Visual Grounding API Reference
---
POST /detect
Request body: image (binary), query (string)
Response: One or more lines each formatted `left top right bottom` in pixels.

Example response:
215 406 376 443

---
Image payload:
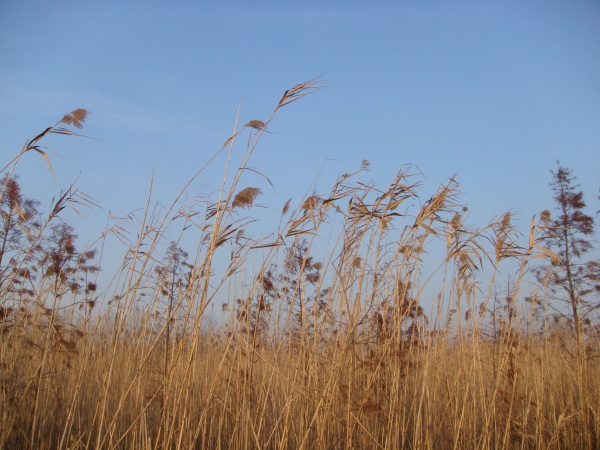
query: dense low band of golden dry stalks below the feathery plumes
2 326 600 448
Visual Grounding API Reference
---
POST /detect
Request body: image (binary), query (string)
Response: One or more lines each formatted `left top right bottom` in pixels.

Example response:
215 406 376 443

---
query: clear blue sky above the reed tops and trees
0 0 600 260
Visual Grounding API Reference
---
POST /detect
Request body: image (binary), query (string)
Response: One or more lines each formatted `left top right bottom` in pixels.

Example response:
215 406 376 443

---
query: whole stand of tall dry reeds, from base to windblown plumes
0 80 600 449
